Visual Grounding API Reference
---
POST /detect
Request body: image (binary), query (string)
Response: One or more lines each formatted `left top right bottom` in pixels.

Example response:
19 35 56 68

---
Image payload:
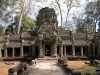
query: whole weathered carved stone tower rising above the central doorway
36 7 61 42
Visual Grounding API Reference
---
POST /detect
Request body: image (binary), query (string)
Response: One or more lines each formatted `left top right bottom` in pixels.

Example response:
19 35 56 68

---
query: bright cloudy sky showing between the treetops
0 0 97 28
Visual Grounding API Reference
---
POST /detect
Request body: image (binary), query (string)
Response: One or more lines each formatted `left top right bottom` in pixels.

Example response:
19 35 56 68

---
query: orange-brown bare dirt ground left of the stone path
0 61 20 75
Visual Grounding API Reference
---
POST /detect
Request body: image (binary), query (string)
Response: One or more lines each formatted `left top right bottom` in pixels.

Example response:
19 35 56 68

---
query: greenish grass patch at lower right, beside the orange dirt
81 64 97 75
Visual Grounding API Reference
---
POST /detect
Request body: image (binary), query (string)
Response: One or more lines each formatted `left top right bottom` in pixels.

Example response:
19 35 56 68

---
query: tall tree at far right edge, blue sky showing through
86 0 100 32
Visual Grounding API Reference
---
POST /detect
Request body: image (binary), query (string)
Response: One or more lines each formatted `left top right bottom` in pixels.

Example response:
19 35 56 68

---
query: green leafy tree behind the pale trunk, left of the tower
5 15 35 34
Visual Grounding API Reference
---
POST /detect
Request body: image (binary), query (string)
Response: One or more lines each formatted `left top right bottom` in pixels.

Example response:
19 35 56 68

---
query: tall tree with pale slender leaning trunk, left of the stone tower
13 0 43 34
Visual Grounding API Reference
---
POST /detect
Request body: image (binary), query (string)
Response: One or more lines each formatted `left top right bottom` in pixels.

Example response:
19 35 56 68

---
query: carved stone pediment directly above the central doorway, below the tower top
37 25 58 40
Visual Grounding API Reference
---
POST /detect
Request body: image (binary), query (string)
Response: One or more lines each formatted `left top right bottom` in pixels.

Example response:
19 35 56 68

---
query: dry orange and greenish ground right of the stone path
68 60 97 75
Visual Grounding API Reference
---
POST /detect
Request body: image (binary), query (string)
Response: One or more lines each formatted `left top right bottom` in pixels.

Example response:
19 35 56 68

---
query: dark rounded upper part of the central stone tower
36 7 58 27
